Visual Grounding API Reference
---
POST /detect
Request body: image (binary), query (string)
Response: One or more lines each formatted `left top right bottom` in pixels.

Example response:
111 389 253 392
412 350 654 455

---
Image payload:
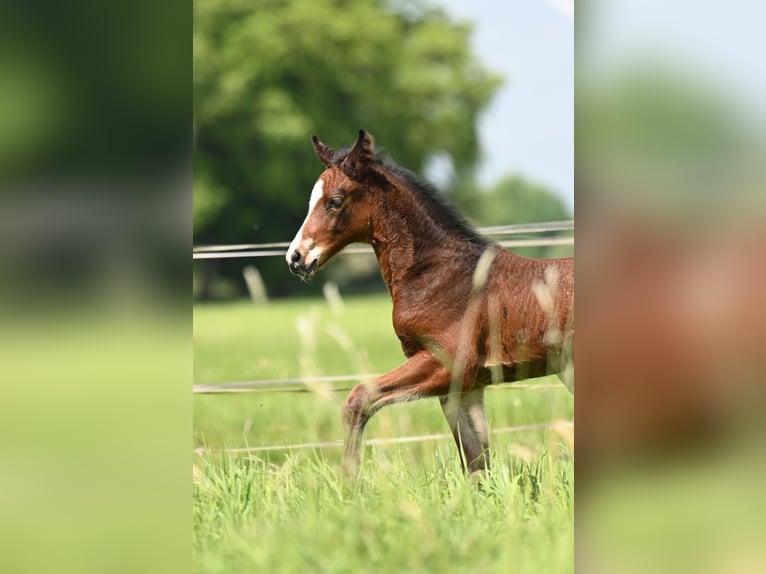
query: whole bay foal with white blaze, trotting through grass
286 130 574 472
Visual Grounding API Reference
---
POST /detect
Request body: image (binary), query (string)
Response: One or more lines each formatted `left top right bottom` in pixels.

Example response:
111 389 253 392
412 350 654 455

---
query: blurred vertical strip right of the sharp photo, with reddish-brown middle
575 1 766 573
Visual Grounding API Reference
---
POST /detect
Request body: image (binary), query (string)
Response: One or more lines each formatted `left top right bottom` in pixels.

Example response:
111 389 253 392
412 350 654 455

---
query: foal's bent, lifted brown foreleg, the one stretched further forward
343 351 450 474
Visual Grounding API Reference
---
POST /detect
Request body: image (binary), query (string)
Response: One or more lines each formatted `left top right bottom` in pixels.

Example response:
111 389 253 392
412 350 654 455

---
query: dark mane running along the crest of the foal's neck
378 156 489 245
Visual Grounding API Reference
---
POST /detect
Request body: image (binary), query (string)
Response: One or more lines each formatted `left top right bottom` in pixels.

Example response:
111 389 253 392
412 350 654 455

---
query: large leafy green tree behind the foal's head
194 0 500 294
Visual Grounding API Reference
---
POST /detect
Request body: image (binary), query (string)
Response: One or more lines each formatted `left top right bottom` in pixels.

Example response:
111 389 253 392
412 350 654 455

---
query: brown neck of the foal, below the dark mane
371 179 484 298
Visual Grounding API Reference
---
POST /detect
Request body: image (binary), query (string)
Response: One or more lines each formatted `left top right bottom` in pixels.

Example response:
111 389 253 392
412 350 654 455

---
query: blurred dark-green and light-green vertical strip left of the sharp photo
0 0 192 572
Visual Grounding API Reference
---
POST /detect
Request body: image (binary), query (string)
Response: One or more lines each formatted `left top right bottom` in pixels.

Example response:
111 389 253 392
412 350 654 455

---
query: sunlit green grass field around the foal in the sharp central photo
193 296 574 573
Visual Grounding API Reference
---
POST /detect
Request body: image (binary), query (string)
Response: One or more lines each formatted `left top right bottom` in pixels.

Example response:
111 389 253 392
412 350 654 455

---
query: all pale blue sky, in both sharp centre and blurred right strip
431 0 766 216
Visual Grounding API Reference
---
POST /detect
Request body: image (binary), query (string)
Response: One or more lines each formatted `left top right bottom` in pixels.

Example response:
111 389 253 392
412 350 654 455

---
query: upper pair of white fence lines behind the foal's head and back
192 220 574 259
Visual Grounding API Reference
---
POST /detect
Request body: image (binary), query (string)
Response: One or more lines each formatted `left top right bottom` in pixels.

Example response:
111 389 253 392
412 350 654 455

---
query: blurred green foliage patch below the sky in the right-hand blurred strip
575 64 763 222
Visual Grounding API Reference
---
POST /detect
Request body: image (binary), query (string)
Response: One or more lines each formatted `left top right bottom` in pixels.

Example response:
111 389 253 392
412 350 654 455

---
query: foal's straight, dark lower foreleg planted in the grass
439 387 489 474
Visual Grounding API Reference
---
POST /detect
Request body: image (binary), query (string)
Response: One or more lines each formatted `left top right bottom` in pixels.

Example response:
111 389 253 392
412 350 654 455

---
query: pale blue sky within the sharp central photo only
433 0 574 210
